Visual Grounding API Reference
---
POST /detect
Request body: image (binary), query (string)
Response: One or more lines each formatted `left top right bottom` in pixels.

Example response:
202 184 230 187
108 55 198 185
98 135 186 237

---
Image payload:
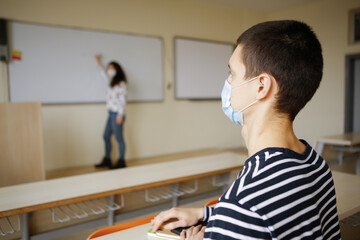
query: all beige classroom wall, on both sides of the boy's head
0 0 360 170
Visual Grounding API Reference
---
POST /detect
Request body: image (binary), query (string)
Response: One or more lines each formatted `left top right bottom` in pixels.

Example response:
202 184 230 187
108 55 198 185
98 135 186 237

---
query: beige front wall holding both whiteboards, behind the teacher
0 0 258 170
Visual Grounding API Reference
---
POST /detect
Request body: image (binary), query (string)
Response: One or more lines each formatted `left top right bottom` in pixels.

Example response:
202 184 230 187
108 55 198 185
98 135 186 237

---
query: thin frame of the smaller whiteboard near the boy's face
173 36 237 101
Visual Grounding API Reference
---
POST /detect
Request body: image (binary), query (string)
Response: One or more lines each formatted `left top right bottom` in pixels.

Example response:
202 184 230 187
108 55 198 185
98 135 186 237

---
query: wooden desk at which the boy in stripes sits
94 171 360 240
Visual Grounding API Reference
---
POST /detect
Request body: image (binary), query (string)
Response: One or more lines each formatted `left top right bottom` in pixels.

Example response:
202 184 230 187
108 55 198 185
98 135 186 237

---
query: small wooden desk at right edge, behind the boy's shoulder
316 131 360 175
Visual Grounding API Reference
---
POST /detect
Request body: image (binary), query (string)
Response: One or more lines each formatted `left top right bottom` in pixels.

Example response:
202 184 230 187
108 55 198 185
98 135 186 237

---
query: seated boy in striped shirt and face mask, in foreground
152 20 340 240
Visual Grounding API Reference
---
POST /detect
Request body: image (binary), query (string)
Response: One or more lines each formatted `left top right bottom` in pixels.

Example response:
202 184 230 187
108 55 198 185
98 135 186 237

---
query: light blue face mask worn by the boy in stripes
221 77 258 126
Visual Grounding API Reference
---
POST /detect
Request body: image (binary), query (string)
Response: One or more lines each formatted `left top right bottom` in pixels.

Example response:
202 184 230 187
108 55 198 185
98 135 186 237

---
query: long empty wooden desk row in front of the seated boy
0 152 247 239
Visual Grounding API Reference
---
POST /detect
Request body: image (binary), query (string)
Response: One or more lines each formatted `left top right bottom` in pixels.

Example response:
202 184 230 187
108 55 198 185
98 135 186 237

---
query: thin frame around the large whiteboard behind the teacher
6 21 165 105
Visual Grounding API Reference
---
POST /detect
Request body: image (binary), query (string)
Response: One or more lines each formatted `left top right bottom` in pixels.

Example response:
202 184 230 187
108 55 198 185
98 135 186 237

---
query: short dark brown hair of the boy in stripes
237 20 323 121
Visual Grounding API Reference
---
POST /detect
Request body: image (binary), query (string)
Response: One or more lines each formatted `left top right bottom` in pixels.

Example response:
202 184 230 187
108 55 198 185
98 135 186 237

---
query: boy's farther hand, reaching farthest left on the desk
151 208 204 232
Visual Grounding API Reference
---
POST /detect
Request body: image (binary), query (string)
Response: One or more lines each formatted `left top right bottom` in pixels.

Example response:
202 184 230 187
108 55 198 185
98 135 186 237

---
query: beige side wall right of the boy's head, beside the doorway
267 0 360 144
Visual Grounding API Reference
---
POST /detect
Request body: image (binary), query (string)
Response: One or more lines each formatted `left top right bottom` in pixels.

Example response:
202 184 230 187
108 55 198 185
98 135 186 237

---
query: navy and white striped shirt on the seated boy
203 140 340 239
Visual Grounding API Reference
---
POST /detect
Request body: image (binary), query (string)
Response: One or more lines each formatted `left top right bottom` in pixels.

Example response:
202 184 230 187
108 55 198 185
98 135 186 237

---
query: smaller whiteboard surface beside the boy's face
175 38 235 100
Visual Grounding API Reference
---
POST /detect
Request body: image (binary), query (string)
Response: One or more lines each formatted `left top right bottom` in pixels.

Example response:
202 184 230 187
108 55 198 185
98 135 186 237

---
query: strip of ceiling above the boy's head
202 0 314 12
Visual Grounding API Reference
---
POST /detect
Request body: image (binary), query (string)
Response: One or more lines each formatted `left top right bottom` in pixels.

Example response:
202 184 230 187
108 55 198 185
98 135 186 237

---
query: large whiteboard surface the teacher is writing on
9 22 163 104
